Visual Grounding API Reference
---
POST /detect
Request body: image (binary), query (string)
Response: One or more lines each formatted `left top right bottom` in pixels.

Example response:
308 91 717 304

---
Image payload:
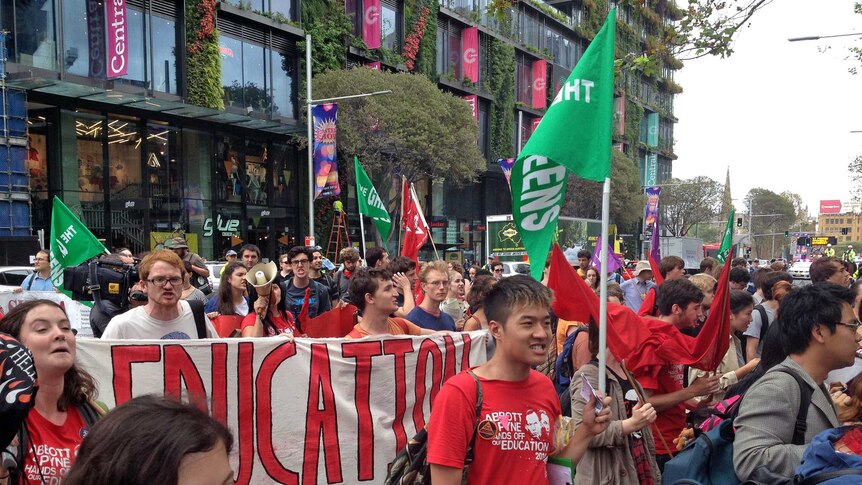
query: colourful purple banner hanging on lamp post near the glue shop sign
311 103 341 199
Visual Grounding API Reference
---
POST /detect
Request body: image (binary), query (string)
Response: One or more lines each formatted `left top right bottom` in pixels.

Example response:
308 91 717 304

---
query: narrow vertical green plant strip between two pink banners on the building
489 38 515 160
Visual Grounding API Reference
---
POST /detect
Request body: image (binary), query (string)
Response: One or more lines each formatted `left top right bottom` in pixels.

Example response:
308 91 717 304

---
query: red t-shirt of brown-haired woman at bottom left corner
24 406 88 483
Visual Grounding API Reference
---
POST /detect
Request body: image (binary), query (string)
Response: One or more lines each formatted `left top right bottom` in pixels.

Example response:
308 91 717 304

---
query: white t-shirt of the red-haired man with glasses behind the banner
102 300 218 340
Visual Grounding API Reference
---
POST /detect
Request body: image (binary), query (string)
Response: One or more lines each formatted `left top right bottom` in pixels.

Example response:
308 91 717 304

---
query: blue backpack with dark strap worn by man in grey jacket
662 367 812 485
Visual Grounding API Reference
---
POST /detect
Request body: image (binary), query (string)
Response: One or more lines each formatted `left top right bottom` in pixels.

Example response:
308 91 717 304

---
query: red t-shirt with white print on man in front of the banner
428 370 561 485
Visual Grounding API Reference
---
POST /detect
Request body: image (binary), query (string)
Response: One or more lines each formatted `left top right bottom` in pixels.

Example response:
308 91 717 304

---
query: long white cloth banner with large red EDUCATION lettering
77 331 488 484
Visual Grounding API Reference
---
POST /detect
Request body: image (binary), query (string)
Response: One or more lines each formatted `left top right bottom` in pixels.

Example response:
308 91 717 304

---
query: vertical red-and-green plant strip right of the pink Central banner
186 0 224 109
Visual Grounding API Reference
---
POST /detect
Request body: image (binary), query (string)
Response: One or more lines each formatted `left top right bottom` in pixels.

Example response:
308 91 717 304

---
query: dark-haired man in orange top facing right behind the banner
346 268 434 338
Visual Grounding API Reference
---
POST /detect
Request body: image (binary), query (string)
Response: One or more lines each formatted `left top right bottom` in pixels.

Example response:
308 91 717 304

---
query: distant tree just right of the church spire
745 188 798 257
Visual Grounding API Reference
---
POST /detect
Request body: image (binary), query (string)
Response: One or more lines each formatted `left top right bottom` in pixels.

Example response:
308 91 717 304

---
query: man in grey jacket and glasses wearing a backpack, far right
733 283 860 481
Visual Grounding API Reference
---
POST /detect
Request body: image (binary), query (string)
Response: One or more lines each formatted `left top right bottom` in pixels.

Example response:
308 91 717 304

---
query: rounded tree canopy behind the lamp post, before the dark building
314 68 485 191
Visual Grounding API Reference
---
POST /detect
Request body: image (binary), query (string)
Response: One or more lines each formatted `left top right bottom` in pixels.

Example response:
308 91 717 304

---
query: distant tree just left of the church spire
660 176 724 237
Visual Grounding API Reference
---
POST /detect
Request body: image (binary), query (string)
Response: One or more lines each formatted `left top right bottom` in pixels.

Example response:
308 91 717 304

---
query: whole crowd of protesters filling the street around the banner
5 241 862 485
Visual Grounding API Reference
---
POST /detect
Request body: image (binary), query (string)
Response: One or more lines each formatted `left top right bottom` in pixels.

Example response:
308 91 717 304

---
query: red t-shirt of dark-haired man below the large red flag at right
635 364 685 455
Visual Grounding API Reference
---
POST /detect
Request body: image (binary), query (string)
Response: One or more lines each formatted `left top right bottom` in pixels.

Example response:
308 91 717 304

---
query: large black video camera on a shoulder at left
63 259 141 311
